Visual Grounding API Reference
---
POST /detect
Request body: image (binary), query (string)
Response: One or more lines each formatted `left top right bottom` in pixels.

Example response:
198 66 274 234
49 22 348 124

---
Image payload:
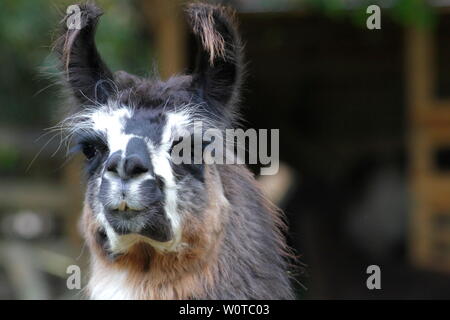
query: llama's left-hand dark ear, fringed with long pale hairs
55 4 115 104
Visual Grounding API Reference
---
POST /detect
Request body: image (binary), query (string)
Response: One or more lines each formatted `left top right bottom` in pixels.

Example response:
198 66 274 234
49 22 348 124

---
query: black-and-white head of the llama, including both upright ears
56 4 242 254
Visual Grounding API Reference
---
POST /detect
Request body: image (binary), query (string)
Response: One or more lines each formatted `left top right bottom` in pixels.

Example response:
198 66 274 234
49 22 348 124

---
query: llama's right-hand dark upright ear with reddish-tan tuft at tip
186 3 242 107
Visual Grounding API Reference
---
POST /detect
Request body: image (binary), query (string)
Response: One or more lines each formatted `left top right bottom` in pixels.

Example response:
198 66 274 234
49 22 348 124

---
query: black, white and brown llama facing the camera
55 3 294 299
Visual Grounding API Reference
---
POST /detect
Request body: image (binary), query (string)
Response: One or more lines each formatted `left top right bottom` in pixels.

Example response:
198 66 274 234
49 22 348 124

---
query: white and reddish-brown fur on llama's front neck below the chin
89 245 222 300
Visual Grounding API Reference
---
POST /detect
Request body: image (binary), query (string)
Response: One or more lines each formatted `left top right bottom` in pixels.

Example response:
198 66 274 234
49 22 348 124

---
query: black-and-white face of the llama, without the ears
72 102 211 253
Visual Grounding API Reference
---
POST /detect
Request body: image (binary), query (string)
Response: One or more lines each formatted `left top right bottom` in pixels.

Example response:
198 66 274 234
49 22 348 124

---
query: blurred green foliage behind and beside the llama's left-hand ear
0 0 151 127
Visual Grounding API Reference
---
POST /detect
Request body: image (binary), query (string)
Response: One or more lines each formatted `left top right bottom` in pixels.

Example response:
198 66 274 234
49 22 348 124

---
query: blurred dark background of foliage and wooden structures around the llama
0 0 450 299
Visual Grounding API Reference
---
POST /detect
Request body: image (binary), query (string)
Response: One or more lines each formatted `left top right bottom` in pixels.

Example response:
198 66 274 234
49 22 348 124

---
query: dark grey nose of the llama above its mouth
106 154 149 179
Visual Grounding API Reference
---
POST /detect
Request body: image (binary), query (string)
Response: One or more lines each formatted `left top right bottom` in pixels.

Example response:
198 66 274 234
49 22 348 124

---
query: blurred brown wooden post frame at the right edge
405 28 450 271
